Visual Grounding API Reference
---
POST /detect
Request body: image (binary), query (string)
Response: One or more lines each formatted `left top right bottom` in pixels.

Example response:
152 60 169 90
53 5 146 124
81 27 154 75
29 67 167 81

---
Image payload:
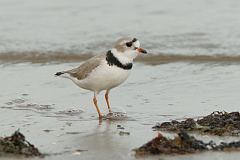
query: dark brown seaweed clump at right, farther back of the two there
153 111 240 136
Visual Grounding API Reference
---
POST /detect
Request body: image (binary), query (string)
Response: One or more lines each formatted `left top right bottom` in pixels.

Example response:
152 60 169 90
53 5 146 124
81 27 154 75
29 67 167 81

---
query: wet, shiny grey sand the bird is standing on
0 62 240 160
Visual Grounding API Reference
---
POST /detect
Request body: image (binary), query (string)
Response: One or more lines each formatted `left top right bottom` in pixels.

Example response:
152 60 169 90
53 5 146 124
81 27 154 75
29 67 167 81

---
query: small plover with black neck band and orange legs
55 37 147 119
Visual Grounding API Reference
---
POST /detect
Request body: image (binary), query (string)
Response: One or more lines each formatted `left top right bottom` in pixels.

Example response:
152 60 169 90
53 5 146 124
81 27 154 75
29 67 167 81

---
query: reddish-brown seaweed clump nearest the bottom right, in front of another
135 131 240 156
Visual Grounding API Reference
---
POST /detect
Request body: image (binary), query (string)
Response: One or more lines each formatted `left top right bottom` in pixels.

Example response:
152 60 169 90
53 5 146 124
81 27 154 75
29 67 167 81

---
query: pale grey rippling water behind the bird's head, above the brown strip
0 0 240 55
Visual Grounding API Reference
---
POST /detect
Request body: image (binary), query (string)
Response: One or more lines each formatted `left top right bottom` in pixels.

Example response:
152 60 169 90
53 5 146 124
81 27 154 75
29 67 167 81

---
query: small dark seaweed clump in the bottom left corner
0 131 43 157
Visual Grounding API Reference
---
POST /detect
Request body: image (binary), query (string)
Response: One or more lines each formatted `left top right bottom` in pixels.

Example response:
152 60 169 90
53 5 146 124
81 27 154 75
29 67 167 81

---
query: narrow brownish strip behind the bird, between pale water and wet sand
3 51 240 65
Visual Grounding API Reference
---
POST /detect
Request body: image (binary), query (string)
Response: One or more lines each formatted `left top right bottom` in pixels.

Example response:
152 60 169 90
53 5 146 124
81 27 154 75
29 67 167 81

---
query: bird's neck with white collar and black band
106 50 133 70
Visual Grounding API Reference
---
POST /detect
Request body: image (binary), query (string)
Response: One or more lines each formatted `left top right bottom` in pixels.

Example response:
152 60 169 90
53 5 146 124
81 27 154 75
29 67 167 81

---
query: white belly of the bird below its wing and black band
72 63 130 92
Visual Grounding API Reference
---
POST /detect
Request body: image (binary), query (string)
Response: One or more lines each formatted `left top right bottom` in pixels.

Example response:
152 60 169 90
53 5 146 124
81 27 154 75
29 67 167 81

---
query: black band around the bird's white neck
106 50 133 70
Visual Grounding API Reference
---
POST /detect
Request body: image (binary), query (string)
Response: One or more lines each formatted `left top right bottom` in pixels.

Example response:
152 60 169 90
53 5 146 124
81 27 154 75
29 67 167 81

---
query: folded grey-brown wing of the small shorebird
65 54 106 80
